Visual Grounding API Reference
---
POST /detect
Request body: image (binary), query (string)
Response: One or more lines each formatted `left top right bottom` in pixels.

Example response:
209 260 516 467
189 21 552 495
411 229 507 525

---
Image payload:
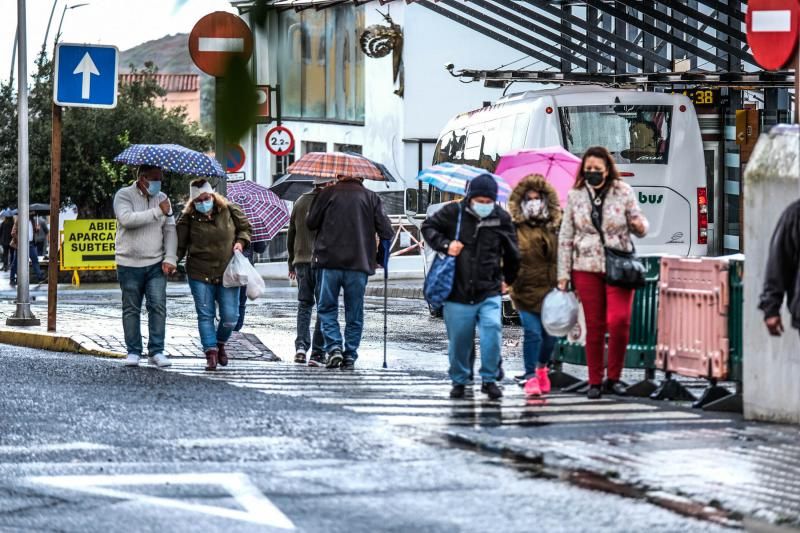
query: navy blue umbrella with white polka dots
114 144 226 178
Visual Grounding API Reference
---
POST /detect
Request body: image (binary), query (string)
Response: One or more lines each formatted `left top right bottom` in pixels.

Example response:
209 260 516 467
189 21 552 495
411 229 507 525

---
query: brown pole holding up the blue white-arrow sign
47 104 61 331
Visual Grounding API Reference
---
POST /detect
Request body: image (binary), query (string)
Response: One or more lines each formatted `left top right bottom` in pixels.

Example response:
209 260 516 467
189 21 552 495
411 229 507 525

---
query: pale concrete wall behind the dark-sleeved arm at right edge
743 130 800 424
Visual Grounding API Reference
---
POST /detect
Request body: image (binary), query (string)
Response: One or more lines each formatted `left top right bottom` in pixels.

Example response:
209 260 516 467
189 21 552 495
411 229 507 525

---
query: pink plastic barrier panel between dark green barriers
656 257 729 379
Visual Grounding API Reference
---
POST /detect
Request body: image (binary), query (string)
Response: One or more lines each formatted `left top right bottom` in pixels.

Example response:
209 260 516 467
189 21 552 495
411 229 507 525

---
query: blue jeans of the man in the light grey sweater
117 263 167 357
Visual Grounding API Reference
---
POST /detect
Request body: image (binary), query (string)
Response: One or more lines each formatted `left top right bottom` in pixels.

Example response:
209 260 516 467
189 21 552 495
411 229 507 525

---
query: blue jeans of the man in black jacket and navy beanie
444 296 503 385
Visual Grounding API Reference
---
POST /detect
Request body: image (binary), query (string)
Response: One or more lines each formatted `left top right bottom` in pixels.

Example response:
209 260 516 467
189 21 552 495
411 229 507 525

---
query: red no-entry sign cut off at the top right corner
745 0 800 70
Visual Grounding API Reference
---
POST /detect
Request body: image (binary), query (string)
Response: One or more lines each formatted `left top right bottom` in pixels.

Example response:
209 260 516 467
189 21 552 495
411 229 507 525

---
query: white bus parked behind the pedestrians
431 86 708 256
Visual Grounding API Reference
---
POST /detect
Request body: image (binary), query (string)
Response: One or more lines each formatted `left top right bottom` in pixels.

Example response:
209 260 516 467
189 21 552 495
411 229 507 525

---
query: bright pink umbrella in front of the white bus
495 146 581 206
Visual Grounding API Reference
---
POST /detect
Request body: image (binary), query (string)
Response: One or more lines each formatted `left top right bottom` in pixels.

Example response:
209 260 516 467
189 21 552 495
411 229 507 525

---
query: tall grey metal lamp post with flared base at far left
6 0 40 326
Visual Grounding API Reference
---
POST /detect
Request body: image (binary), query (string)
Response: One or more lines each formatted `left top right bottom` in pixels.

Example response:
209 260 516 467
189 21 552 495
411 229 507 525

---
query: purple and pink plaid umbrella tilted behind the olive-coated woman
228 180 289 242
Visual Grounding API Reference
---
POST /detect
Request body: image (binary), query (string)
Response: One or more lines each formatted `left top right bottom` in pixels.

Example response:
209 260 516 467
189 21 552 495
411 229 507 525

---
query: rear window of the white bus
558 104 672 164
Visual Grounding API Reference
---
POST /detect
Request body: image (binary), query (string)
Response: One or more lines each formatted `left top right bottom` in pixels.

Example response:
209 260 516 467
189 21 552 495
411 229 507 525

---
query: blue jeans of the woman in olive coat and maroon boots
189 278 239 352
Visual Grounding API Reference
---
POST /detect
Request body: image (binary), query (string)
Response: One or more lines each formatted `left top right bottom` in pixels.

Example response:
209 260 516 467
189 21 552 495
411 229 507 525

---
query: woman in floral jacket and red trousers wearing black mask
558 146 648 400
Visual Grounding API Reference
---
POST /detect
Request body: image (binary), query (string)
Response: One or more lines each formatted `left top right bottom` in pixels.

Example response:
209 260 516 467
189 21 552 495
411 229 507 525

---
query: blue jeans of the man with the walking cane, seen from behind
317 268 369 359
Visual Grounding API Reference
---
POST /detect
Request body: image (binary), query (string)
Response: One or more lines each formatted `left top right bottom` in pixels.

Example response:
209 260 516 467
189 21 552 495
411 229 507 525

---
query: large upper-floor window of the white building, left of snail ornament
278 5 364 122
